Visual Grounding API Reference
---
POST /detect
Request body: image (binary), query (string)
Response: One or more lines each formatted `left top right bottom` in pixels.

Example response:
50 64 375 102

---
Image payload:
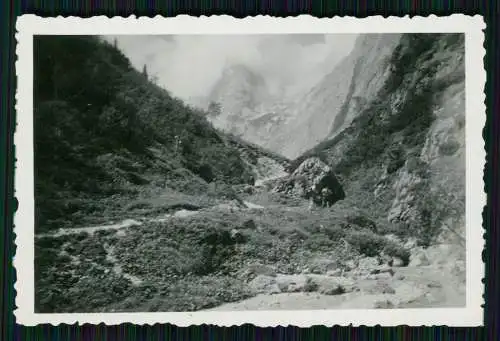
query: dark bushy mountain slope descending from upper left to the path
34 36 283 229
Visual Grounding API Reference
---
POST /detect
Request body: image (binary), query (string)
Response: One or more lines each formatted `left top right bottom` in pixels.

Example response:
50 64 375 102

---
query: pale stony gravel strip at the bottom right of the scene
206 246 465 310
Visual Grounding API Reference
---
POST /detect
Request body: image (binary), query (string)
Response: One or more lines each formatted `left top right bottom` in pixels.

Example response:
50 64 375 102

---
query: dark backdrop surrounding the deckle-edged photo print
0 0 500 341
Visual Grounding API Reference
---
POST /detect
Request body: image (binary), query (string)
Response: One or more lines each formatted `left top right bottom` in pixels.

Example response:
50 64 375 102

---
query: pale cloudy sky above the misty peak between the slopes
107 34 356 99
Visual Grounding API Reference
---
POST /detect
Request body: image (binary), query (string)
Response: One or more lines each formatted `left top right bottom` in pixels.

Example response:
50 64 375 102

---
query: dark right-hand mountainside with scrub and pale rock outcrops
294 34 465 244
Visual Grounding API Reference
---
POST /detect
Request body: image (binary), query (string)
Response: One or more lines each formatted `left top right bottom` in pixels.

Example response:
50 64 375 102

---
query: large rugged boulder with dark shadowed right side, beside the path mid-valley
273 157 345 205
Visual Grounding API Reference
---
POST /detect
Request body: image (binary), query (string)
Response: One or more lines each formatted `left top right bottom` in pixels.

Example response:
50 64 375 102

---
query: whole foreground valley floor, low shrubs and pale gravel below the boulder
36 185 465 312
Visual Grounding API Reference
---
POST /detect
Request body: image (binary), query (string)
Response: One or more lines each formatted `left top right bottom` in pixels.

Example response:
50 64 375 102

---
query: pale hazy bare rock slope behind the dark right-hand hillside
268 34 400 158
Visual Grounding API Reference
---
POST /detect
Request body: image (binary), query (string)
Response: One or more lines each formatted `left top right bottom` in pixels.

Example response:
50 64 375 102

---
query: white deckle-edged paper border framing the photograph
14 15 486 327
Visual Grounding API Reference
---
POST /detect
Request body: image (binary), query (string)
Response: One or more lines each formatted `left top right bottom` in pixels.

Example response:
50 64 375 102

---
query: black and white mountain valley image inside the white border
16 15 484 324
